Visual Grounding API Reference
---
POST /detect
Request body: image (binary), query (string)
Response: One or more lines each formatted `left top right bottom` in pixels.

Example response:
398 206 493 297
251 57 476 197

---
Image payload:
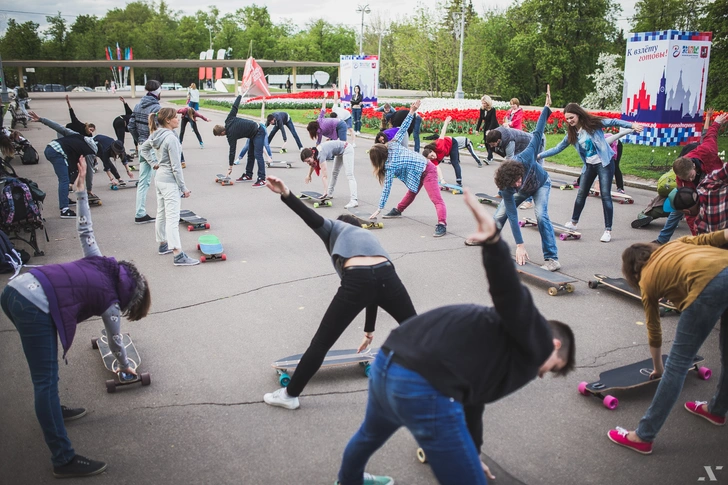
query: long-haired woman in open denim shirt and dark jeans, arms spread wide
538 103 642 242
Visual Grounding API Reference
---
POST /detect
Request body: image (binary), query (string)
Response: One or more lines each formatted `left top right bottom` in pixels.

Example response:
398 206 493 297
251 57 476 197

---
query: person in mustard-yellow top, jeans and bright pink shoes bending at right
607 229 728 455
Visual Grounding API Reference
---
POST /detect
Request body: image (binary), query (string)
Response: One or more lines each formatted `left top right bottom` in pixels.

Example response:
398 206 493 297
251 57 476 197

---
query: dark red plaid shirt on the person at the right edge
695 165 728 234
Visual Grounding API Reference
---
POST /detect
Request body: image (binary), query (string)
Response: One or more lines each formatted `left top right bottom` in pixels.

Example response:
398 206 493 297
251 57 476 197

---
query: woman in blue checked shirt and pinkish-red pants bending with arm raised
369 101 447 237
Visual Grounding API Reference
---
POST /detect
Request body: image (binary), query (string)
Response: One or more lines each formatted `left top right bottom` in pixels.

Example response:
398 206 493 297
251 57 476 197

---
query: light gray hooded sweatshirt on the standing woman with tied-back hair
141 128 187 192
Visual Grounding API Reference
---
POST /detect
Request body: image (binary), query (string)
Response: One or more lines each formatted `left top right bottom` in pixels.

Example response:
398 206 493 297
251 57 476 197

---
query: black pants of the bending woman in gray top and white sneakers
288 264 417 397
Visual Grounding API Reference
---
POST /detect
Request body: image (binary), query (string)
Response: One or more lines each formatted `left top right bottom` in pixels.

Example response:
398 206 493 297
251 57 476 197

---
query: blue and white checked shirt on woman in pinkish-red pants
379 113 429 209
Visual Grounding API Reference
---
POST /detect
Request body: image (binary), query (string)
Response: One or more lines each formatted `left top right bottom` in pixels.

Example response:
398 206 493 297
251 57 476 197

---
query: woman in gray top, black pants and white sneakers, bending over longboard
263 176 417 409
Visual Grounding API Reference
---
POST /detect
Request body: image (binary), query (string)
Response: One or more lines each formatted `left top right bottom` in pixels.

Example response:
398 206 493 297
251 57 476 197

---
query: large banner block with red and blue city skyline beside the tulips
622 30 712 146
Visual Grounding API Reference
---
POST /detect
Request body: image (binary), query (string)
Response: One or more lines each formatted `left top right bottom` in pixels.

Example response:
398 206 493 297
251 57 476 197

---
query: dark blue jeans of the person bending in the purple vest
0 286 76 466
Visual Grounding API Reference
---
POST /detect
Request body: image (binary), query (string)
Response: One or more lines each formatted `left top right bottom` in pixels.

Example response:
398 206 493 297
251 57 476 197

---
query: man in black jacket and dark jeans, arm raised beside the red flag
212 96 266 187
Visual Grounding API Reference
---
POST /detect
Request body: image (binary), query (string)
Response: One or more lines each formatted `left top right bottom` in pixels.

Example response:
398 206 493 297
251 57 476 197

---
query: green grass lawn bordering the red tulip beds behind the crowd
178 99 728 180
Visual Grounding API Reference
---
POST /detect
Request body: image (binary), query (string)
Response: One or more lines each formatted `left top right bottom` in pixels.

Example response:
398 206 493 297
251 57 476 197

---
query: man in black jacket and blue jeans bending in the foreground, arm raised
339 189 575 485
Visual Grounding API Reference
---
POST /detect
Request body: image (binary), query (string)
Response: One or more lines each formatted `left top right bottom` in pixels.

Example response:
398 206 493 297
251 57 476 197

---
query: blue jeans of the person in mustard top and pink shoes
637 268 728 442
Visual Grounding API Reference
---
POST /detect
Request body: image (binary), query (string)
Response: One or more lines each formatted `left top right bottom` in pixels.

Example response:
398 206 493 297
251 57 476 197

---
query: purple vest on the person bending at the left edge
30 256 136 357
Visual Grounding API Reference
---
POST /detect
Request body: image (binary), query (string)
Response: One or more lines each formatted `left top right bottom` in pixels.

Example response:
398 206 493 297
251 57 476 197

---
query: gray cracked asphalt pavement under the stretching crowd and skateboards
0 93 728 485
